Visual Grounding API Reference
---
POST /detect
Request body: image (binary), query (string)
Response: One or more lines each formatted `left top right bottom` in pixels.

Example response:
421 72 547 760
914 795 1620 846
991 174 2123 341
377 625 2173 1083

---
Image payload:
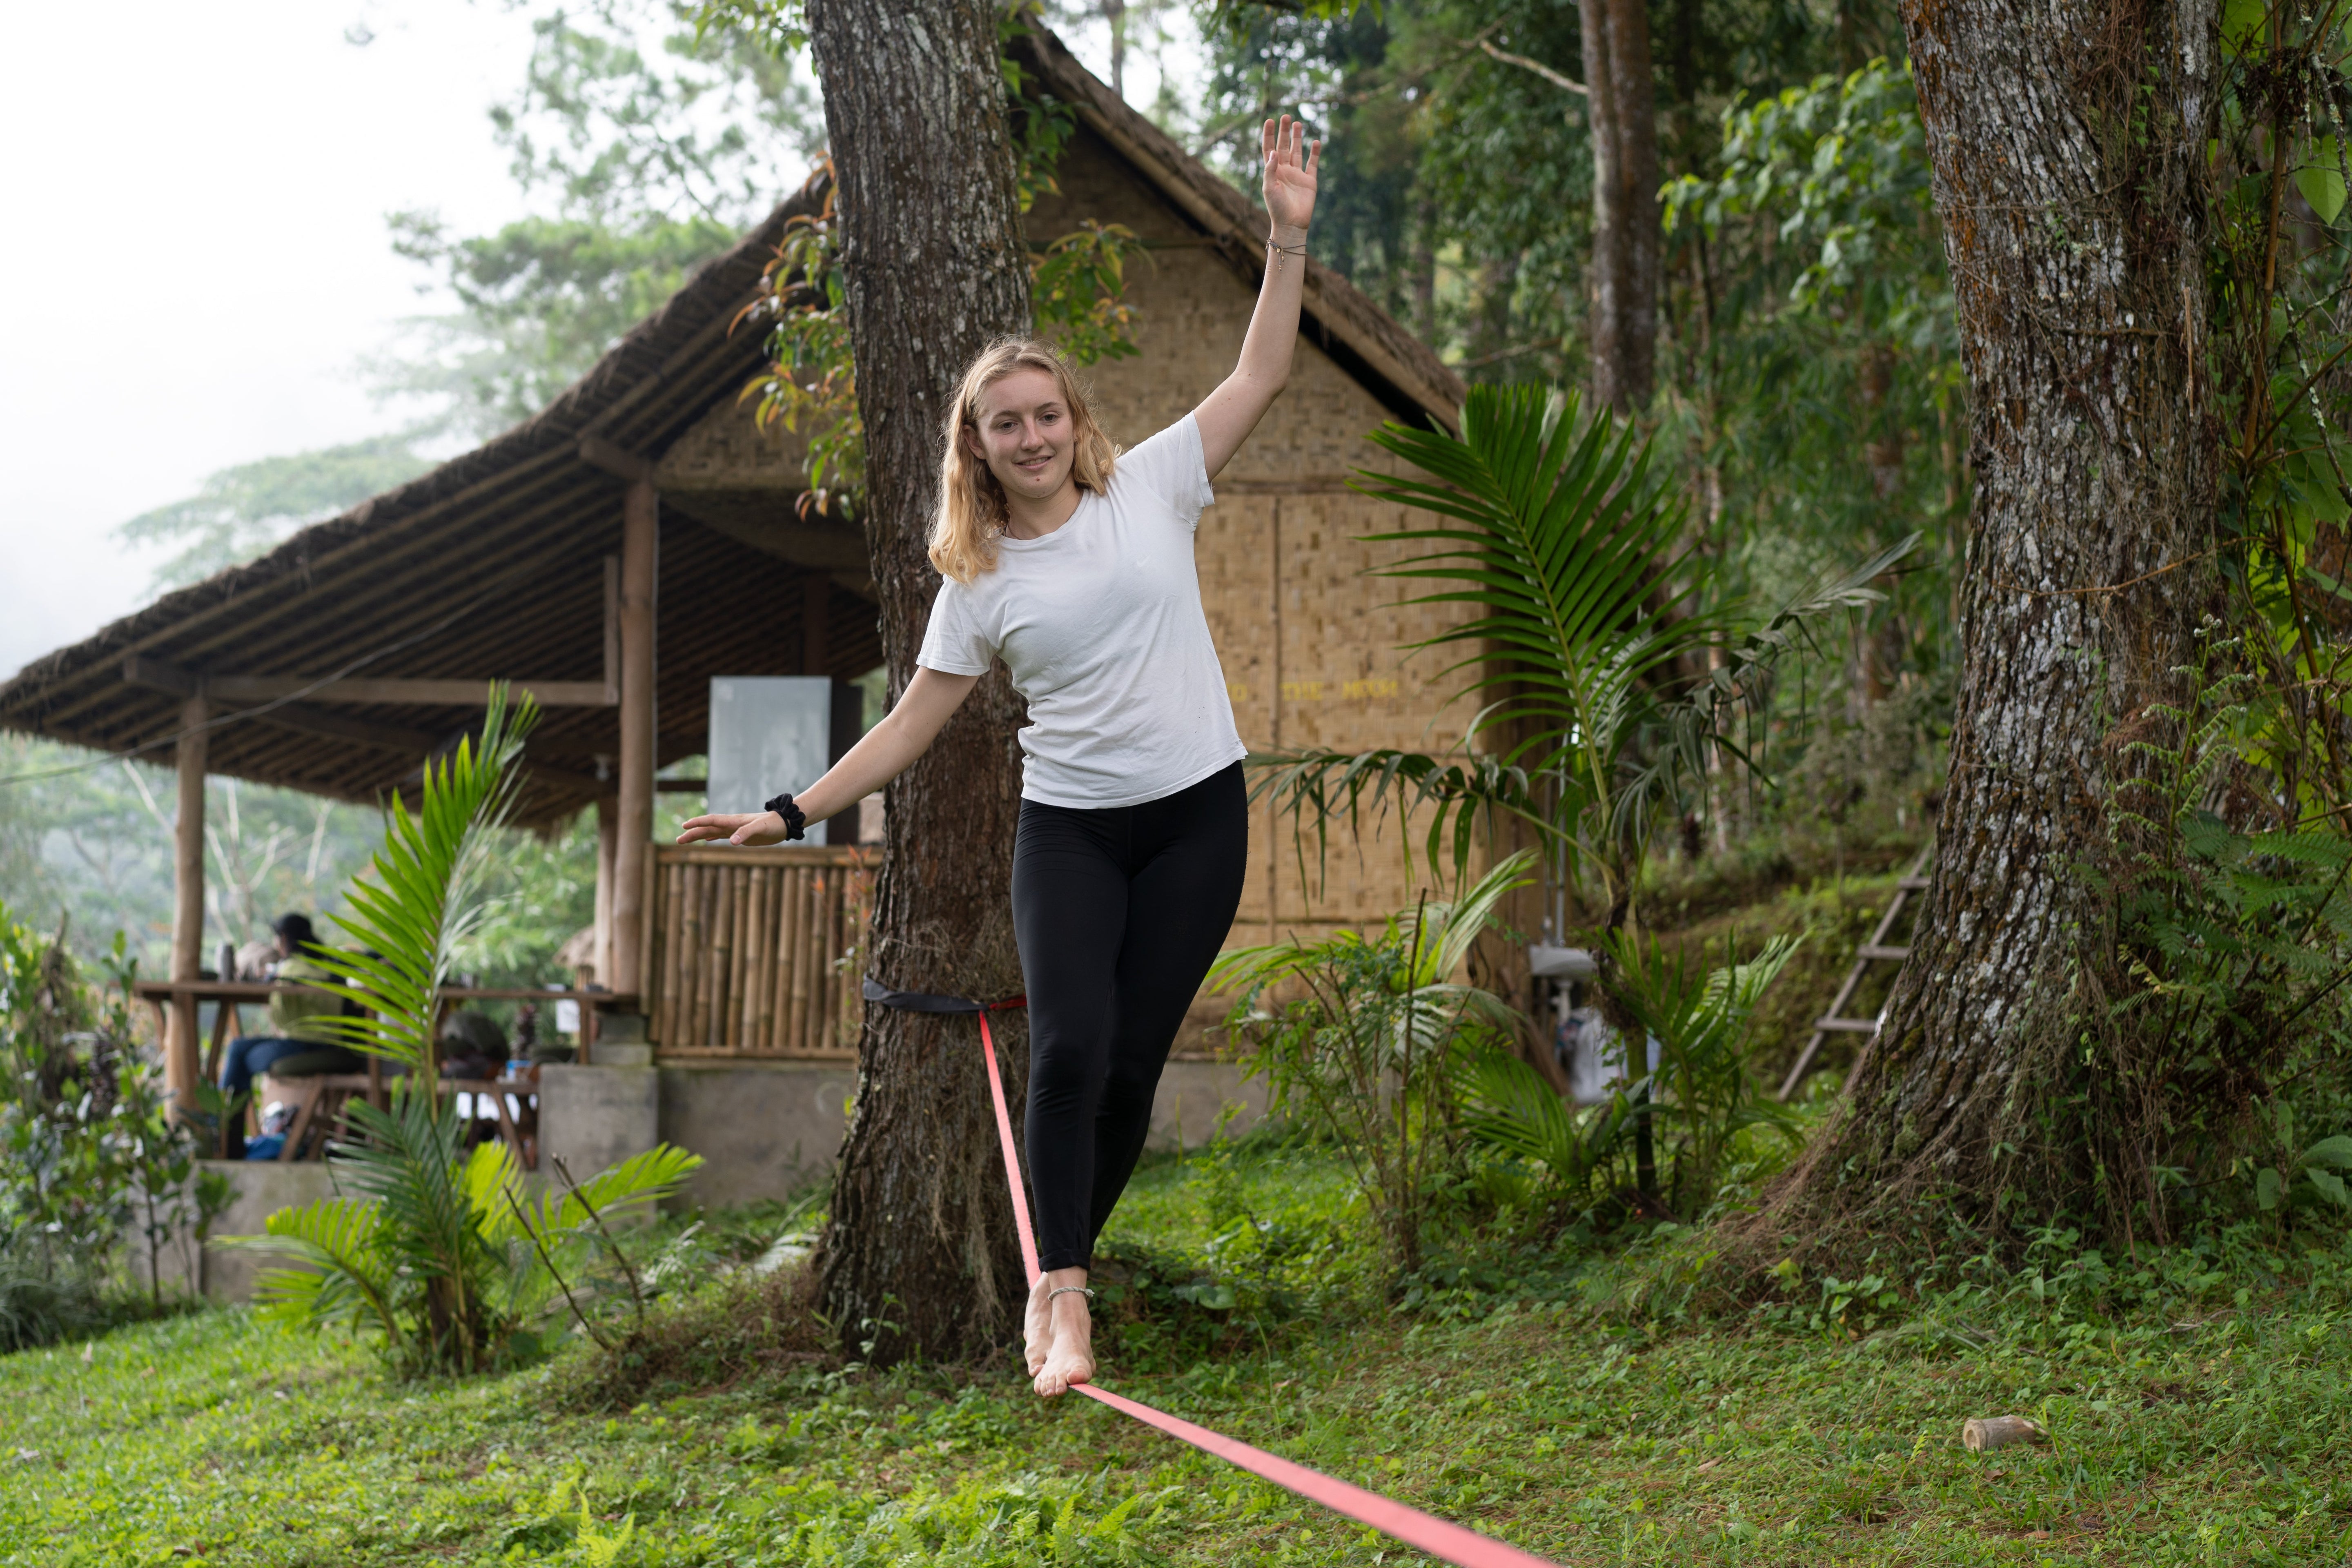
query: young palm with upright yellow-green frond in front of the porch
219 684 701 1373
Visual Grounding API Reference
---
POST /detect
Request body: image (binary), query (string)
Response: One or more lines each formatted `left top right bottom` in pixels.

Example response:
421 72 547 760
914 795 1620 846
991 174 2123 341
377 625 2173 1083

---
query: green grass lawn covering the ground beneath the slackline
0 1145 2352 1568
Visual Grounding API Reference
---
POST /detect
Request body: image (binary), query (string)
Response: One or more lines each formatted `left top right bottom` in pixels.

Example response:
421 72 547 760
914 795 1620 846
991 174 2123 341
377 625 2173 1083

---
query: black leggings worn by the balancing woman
1014 762 1249 1270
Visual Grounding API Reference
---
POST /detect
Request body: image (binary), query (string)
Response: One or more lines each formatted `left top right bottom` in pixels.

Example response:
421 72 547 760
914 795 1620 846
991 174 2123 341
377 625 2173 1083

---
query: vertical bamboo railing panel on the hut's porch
644 844 880 1060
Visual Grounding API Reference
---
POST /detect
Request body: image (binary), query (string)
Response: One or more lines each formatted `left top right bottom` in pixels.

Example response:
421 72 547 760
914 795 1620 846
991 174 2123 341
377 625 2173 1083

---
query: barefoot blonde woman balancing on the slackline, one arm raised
677 118 1322 1394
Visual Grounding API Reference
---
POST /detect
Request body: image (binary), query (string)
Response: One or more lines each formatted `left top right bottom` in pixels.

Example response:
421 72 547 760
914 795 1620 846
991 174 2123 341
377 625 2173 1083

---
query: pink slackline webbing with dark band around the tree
866 976 1557 1568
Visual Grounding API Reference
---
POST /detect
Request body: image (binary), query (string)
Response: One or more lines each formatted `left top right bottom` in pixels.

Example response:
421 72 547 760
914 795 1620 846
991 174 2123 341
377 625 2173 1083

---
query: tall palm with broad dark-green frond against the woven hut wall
1256 385 1912 929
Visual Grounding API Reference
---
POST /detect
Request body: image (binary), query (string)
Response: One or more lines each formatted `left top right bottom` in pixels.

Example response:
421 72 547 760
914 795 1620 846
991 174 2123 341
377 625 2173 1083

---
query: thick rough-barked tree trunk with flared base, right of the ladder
1783 0 2216 1239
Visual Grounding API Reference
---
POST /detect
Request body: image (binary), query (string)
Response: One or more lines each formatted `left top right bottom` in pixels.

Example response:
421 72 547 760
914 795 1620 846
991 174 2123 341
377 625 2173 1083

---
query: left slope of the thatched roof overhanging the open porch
0 169 880 820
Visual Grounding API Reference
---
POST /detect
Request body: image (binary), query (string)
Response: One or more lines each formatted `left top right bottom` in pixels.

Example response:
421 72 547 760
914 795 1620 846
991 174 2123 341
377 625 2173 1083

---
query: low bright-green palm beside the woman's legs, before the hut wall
1209 851 1534 1272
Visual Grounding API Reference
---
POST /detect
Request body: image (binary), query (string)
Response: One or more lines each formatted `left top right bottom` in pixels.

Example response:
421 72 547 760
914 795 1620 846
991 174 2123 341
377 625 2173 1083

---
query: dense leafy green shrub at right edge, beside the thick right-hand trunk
2063 621 2352 1239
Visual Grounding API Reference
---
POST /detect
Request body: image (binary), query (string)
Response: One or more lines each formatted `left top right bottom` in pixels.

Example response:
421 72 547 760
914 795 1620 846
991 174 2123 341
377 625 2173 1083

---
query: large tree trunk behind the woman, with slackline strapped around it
809 0 1030 1361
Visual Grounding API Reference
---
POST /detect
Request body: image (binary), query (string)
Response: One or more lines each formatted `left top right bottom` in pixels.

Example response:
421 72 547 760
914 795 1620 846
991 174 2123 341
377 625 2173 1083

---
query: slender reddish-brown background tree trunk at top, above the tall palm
1581 0 1661 414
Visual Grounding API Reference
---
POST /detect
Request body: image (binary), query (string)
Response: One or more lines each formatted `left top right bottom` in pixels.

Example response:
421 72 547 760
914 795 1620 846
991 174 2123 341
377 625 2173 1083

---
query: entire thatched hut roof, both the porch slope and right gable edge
0 31 1463 823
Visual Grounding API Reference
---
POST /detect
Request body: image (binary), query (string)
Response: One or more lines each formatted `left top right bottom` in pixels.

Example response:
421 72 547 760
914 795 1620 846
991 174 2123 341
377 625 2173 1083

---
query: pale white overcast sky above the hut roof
0 0 1176 677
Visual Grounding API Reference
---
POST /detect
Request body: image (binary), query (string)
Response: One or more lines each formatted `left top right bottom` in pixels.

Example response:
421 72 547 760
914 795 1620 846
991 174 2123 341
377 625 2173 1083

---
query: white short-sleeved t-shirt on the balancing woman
915 414 1249 808
